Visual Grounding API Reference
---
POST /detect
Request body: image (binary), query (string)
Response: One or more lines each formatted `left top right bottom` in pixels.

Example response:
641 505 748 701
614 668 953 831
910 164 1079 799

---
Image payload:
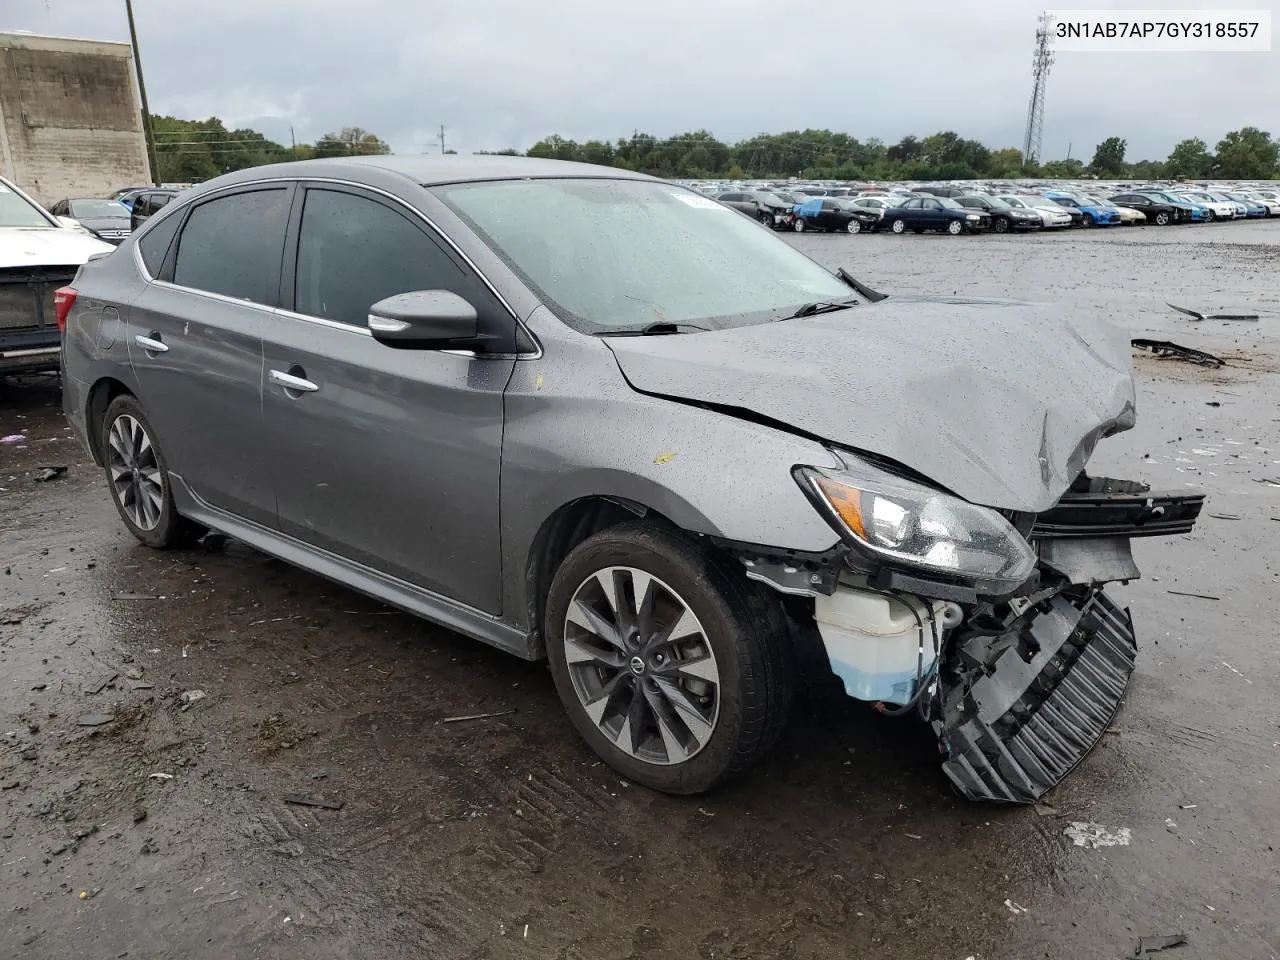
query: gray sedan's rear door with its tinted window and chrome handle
127 183 293 526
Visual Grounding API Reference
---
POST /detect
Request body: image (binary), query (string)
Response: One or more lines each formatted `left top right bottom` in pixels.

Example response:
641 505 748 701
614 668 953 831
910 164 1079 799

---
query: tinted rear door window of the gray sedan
173 187 289 303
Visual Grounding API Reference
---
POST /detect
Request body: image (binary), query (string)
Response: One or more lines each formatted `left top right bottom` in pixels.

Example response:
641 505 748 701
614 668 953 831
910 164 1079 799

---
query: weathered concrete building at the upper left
0 33 151 205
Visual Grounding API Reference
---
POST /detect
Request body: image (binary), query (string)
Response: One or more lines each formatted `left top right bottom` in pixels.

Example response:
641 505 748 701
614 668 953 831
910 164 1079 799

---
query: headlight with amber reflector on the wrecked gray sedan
796 461 1036 594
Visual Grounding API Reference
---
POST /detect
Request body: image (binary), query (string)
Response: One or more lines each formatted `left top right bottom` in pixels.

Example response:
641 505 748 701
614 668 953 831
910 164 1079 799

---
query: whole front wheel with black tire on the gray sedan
544 524 794 795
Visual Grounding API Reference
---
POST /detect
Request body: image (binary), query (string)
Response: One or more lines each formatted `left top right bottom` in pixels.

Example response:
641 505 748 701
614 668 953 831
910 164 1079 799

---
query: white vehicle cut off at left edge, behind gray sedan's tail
0 177 115 374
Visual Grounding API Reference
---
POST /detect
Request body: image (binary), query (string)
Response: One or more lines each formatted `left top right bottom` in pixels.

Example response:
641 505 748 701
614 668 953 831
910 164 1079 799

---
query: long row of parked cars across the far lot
716 186 1280 234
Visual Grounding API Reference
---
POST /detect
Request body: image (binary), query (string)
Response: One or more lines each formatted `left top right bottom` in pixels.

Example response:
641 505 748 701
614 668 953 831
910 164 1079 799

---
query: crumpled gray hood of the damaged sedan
605 296 1134 511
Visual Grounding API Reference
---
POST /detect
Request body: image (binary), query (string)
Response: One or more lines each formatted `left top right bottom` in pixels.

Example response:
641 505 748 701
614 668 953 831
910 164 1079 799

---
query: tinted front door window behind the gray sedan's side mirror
293 188 471 326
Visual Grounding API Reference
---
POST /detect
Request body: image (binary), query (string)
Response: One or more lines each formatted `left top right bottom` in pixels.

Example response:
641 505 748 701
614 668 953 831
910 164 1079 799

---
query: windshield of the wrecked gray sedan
434 179 854 333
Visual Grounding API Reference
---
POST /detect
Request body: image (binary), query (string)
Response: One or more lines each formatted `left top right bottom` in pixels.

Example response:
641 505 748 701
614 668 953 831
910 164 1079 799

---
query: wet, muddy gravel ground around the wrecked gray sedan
0 223 1280 960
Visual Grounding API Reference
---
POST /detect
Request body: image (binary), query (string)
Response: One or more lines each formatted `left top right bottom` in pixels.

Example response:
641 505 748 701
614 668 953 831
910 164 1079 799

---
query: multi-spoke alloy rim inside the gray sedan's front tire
564 567 721 765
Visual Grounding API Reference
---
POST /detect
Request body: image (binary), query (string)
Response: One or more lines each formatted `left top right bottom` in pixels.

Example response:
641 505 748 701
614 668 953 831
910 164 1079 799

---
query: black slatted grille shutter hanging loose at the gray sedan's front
936 590 1138 803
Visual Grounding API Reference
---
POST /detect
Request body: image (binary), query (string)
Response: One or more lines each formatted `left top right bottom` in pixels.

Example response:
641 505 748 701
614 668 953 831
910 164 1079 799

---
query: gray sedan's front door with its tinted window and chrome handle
262 186 515 614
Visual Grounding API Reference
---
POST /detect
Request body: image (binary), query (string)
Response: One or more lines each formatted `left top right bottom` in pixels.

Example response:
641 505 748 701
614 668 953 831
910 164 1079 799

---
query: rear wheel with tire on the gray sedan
99 393 205 549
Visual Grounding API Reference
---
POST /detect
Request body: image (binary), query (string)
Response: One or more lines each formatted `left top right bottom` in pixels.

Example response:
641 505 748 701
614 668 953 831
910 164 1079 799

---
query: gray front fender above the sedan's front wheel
500 310 840 626
